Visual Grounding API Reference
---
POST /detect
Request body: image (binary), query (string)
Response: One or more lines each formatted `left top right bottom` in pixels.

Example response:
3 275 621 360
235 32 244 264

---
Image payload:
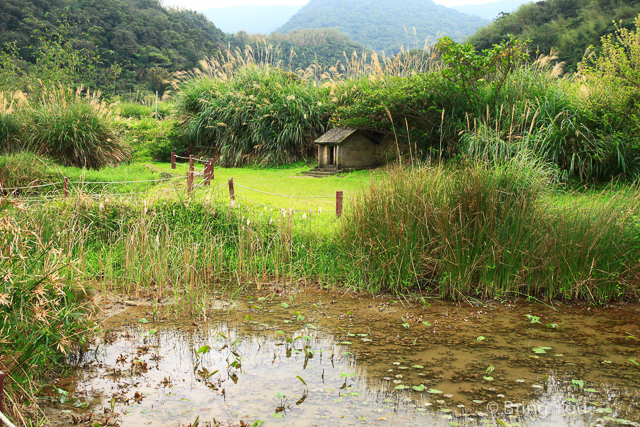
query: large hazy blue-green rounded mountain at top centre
277 0 488 55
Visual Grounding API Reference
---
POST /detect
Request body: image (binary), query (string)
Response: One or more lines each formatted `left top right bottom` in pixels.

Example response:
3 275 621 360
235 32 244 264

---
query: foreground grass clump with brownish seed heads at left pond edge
0 200 90 421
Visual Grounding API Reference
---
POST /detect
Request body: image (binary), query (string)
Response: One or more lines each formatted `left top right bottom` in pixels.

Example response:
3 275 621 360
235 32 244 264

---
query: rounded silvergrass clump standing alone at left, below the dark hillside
22 87 130 169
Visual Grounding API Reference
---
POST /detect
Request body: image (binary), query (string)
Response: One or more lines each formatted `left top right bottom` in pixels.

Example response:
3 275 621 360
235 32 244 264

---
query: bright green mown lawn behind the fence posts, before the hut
6 162 375 212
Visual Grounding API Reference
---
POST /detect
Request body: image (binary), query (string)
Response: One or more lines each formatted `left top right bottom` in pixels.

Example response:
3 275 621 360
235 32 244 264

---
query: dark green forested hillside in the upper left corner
0 0 224 90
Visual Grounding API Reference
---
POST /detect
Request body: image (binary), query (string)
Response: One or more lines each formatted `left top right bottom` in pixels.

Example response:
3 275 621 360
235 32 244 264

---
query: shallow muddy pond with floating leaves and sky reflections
56 293 640 426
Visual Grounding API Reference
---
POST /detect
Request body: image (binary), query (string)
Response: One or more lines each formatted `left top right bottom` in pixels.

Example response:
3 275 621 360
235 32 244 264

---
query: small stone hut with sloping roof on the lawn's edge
315 128 379 172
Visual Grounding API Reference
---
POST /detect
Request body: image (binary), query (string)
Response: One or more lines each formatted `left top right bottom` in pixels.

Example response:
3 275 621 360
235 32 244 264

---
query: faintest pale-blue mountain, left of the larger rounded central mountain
201 5 302 34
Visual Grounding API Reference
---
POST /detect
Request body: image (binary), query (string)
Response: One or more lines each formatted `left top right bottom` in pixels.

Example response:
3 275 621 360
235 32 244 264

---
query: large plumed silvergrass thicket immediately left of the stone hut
177 66 332 166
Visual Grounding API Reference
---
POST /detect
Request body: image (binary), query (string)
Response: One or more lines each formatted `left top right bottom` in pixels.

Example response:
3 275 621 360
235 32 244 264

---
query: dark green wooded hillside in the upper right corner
469 0 640 71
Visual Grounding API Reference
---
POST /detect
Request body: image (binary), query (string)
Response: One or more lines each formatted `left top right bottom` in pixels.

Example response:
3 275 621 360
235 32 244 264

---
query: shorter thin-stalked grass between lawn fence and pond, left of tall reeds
7 195 341 300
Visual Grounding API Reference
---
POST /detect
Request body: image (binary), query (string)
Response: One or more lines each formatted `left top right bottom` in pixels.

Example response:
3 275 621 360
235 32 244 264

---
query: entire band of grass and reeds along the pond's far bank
8 160 640 304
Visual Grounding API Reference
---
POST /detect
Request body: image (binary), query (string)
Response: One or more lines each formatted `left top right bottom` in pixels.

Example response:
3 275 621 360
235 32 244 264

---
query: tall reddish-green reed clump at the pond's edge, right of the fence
343 156 640 302
